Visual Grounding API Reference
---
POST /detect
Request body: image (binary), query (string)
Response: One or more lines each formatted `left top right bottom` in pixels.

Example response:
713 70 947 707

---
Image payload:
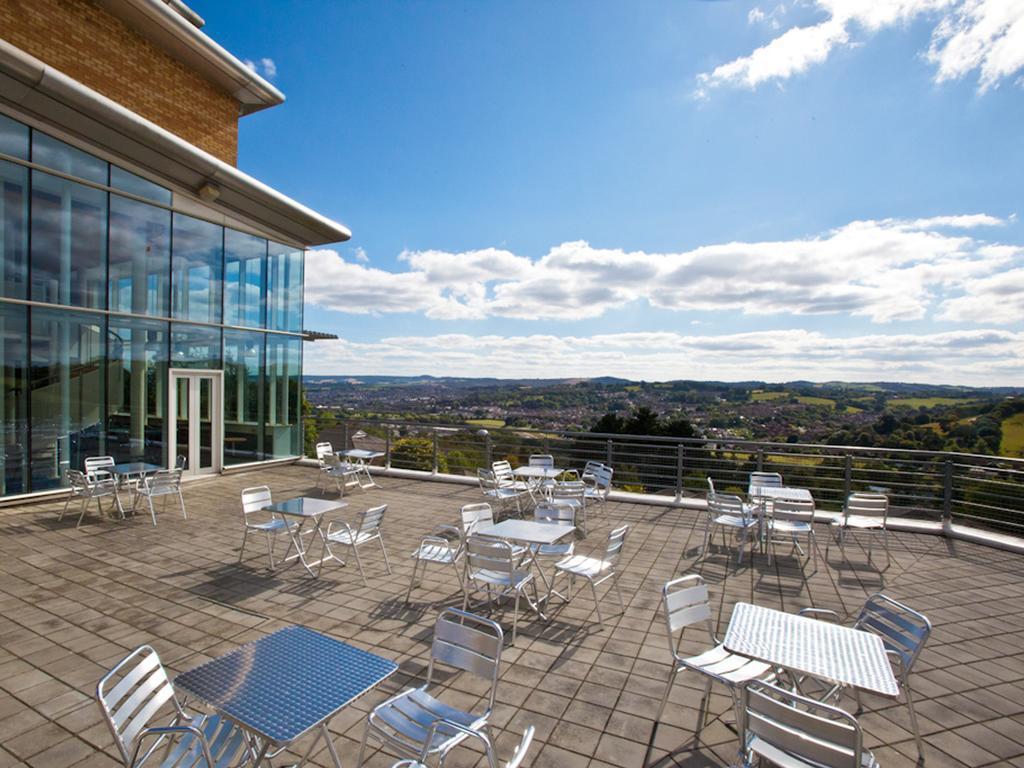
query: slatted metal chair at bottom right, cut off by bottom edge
742 683 879 768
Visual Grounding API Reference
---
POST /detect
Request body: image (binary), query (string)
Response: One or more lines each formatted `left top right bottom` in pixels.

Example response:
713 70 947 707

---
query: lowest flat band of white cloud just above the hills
304 330 1024 386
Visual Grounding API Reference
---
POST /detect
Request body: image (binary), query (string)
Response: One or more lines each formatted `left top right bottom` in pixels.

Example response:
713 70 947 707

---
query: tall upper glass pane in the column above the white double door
171 213 224 323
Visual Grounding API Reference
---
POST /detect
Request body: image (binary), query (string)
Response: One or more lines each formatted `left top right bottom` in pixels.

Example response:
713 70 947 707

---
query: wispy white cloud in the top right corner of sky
695 0 1024 97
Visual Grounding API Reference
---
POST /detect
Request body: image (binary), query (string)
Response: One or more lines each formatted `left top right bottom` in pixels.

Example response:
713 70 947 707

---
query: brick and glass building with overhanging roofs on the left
0 0 348 497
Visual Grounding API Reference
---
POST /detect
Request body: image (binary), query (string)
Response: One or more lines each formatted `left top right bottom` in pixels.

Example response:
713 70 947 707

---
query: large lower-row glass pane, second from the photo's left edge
30 308 104 490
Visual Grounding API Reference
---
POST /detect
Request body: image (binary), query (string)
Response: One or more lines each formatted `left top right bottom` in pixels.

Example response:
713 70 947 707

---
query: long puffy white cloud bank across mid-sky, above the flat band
306 214 1024 323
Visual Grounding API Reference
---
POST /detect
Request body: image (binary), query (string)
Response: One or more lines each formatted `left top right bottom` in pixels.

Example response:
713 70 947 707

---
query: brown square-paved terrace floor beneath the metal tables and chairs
0 466 1024 768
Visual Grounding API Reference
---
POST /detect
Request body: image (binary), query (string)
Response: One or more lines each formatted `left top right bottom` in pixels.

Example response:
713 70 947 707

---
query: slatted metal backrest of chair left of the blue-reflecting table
96 645 184 765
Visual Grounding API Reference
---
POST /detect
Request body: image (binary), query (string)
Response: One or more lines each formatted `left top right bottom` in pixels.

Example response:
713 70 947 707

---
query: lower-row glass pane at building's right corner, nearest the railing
263 334 302 459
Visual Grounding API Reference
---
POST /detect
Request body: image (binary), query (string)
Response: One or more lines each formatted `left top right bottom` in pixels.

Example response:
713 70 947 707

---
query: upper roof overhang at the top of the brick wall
98 0 285 115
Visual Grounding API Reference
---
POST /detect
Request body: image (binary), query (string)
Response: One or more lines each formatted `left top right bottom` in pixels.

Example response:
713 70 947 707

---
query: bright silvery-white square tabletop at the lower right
724 603 899 697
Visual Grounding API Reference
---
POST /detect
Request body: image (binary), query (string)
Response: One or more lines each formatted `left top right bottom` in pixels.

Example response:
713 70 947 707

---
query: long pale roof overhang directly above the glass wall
0 40 352 246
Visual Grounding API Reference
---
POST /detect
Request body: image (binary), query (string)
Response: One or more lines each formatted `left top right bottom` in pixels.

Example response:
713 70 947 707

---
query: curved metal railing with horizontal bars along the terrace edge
307 415 1024 536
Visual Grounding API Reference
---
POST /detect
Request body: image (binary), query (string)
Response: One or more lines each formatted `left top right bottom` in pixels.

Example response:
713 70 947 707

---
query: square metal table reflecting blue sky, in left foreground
174 627 398 768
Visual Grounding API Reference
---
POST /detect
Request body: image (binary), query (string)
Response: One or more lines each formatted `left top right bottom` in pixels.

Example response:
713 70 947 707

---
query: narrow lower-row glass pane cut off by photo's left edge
0 304 29 496
